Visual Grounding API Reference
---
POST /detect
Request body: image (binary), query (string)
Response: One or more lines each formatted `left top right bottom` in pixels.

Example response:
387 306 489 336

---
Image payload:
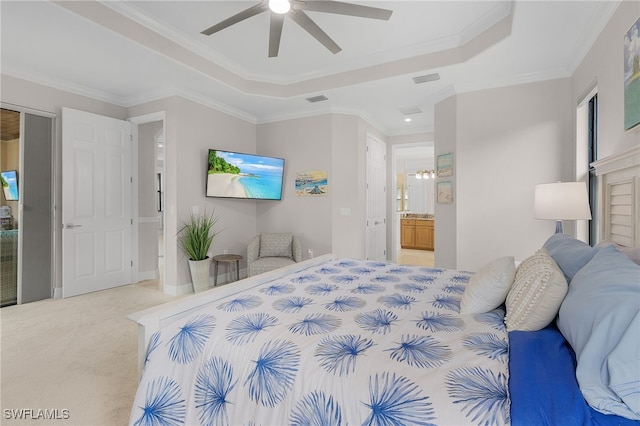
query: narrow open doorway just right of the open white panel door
130 113 166 290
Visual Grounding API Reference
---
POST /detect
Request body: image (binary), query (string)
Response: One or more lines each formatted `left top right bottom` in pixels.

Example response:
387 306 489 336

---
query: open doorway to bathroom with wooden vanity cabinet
392 142 435 266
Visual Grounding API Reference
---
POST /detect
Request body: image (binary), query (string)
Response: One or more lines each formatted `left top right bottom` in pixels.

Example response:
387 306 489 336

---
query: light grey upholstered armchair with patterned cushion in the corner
247 233 302 276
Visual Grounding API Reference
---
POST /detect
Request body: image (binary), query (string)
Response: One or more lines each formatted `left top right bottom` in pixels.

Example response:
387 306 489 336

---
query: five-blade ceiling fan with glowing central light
202 0 393 58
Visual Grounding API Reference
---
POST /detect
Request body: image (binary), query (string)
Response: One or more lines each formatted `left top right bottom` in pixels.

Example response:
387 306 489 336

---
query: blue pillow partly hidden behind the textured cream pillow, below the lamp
542 234 598 284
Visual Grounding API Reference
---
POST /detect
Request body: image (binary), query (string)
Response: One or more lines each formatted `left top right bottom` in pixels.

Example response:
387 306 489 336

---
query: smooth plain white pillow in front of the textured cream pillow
460 256 516 314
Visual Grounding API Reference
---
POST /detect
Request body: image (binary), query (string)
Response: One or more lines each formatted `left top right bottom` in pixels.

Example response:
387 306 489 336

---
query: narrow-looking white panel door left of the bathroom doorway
366 135 387 260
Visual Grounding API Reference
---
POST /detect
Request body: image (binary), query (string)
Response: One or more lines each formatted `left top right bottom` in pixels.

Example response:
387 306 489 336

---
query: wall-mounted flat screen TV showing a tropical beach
207 149 284 200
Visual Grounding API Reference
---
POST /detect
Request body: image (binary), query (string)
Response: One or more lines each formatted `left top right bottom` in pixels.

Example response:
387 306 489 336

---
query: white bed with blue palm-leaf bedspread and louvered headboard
130 148 640 425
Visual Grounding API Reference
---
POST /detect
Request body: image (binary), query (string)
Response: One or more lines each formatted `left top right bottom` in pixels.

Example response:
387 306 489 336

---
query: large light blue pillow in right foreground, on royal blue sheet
558 246 640 420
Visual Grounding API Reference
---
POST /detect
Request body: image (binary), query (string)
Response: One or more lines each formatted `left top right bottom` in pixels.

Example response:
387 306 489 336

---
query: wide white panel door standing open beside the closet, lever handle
62 108 133 297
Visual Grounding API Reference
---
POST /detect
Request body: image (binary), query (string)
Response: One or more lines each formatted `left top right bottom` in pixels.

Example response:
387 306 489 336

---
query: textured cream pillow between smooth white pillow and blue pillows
504 249 569 331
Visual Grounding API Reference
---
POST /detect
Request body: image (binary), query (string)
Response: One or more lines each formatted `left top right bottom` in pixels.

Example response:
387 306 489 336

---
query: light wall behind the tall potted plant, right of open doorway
130 97 258 294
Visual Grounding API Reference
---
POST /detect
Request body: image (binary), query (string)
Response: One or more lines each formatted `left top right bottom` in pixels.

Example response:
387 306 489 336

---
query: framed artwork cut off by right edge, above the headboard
624 18 640 130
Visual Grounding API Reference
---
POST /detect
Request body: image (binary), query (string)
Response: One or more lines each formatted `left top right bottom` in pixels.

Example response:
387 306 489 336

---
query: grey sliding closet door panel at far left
18 113 53 303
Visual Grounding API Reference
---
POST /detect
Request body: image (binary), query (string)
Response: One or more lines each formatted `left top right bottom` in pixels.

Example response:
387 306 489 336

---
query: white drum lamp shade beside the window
534 182 591 220
